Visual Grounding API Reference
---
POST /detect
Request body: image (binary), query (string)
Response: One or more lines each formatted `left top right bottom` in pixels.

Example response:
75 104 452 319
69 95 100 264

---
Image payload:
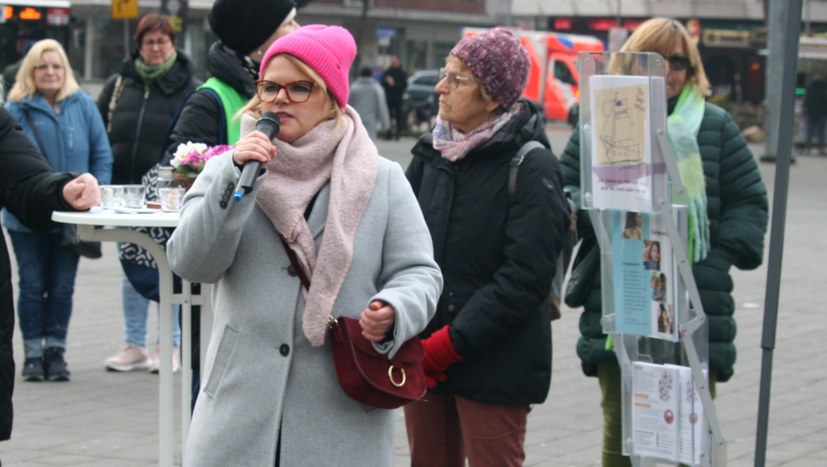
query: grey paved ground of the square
0 125 827 467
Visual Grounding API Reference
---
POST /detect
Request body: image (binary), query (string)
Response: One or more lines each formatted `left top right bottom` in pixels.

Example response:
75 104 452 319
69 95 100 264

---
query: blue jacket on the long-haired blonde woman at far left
3 91 112 232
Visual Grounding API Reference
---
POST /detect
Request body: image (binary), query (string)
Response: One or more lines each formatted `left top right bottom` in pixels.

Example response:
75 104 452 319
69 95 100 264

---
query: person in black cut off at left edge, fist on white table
0 106 100 441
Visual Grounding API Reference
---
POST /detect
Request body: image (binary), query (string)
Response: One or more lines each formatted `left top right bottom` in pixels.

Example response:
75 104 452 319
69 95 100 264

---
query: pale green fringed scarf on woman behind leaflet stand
666 85 709 264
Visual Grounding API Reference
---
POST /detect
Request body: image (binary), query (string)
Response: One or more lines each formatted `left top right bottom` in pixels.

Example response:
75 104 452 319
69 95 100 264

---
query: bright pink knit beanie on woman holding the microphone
258 24 356 108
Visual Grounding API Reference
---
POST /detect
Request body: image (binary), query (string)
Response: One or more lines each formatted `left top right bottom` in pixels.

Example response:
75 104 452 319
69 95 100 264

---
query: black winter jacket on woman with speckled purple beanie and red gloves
407 101 569 405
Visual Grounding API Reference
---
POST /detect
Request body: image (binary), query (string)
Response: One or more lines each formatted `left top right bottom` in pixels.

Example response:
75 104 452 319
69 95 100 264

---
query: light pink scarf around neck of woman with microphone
241 107 379 347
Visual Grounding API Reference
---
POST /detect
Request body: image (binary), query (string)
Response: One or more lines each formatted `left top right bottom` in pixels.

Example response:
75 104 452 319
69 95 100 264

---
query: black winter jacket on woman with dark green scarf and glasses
98 50 200 184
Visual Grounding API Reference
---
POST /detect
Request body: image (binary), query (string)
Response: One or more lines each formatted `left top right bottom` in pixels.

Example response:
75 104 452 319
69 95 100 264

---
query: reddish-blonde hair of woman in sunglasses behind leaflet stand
620 18 710 95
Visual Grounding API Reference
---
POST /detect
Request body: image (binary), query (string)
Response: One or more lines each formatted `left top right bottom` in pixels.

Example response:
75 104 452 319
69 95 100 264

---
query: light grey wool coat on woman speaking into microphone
167 153 442 467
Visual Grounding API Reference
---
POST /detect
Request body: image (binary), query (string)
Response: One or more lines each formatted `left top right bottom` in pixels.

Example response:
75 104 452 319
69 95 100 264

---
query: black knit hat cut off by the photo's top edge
209 0 296 55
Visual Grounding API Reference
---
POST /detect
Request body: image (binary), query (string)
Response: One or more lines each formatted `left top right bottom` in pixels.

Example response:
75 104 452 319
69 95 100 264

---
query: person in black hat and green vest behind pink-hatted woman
164 0 299 410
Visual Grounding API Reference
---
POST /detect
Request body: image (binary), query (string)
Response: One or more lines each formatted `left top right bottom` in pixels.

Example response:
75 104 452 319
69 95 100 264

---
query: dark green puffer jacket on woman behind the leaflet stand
560 99 768 382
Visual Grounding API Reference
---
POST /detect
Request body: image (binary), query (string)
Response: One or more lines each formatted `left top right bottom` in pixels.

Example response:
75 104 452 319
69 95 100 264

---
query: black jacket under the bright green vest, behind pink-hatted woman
165 42 255 161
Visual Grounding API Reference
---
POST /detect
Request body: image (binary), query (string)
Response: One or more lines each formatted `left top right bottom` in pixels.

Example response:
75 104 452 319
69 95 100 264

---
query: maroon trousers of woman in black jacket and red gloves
405 393 531 467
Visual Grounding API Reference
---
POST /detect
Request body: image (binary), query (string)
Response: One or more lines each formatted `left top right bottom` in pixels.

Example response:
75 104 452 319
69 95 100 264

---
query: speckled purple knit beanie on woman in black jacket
451 28 529 109
